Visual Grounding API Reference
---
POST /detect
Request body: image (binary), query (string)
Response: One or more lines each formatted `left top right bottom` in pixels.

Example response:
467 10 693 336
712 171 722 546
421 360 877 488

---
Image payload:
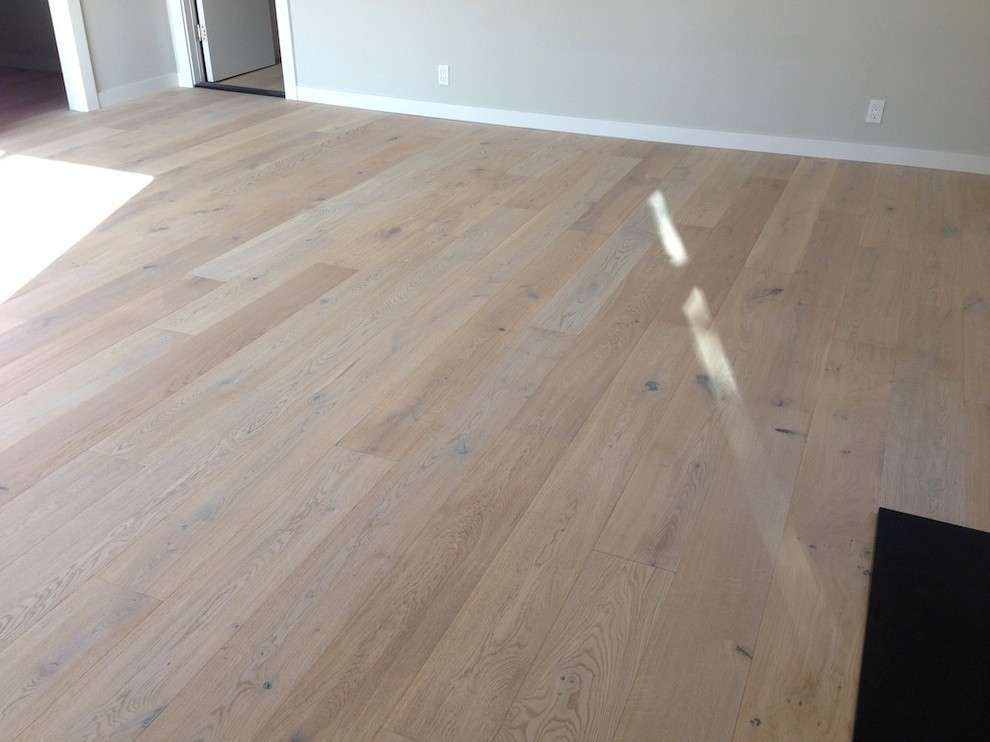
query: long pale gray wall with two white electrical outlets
291 0 990 155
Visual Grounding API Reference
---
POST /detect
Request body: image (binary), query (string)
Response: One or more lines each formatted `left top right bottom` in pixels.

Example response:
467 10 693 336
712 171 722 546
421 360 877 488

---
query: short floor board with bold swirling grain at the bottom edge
495 552 673 742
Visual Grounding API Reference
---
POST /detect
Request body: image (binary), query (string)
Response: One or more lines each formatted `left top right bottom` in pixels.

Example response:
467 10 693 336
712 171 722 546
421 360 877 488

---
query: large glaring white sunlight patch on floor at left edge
0 155 153 301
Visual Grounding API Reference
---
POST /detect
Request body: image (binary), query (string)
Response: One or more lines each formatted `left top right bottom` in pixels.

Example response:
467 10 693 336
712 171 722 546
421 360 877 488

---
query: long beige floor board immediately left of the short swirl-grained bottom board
386 325 689 739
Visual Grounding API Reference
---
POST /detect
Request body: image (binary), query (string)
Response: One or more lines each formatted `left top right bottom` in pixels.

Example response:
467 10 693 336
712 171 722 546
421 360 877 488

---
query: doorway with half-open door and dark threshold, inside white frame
196 0 285 97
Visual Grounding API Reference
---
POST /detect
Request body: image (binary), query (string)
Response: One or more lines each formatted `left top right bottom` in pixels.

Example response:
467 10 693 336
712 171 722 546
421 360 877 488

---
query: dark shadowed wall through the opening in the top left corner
0 0 59 72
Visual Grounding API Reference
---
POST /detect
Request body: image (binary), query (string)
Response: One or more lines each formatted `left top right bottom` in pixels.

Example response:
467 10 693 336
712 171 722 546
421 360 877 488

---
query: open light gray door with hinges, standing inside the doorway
196 0 275 82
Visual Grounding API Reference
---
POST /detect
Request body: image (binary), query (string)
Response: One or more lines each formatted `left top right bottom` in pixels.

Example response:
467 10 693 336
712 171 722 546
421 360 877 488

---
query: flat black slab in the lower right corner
854 509 990 742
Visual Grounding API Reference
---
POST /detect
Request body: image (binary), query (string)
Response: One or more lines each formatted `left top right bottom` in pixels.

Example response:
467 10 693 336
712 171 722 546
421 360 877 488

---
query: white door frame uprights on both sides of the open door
161 0 299 100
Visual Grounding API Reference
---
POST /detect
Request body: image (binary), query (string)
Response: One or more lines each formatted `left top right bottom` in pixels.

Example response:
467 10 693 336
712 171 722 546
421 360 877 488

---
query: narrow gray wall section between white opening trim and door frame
82 0 175 93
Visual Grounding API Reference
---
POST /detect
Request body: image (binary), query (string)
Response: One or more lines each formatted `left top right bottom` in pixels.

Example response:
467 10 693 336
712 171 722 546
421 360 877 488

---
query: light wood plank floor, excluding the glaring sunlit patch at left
0 67 990 742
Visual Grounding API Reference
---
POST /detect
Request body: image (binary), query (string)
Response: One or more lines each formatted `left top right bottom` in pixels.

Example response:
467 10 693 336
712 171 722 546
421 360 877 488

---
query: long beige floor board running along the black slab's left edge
735 341 893 740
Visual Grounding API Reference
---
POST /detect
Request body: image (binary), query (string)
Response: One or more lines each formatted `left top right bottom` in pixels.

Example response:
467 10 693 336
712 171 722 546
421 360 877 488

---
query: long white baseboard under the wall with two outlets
297 86 990 175
